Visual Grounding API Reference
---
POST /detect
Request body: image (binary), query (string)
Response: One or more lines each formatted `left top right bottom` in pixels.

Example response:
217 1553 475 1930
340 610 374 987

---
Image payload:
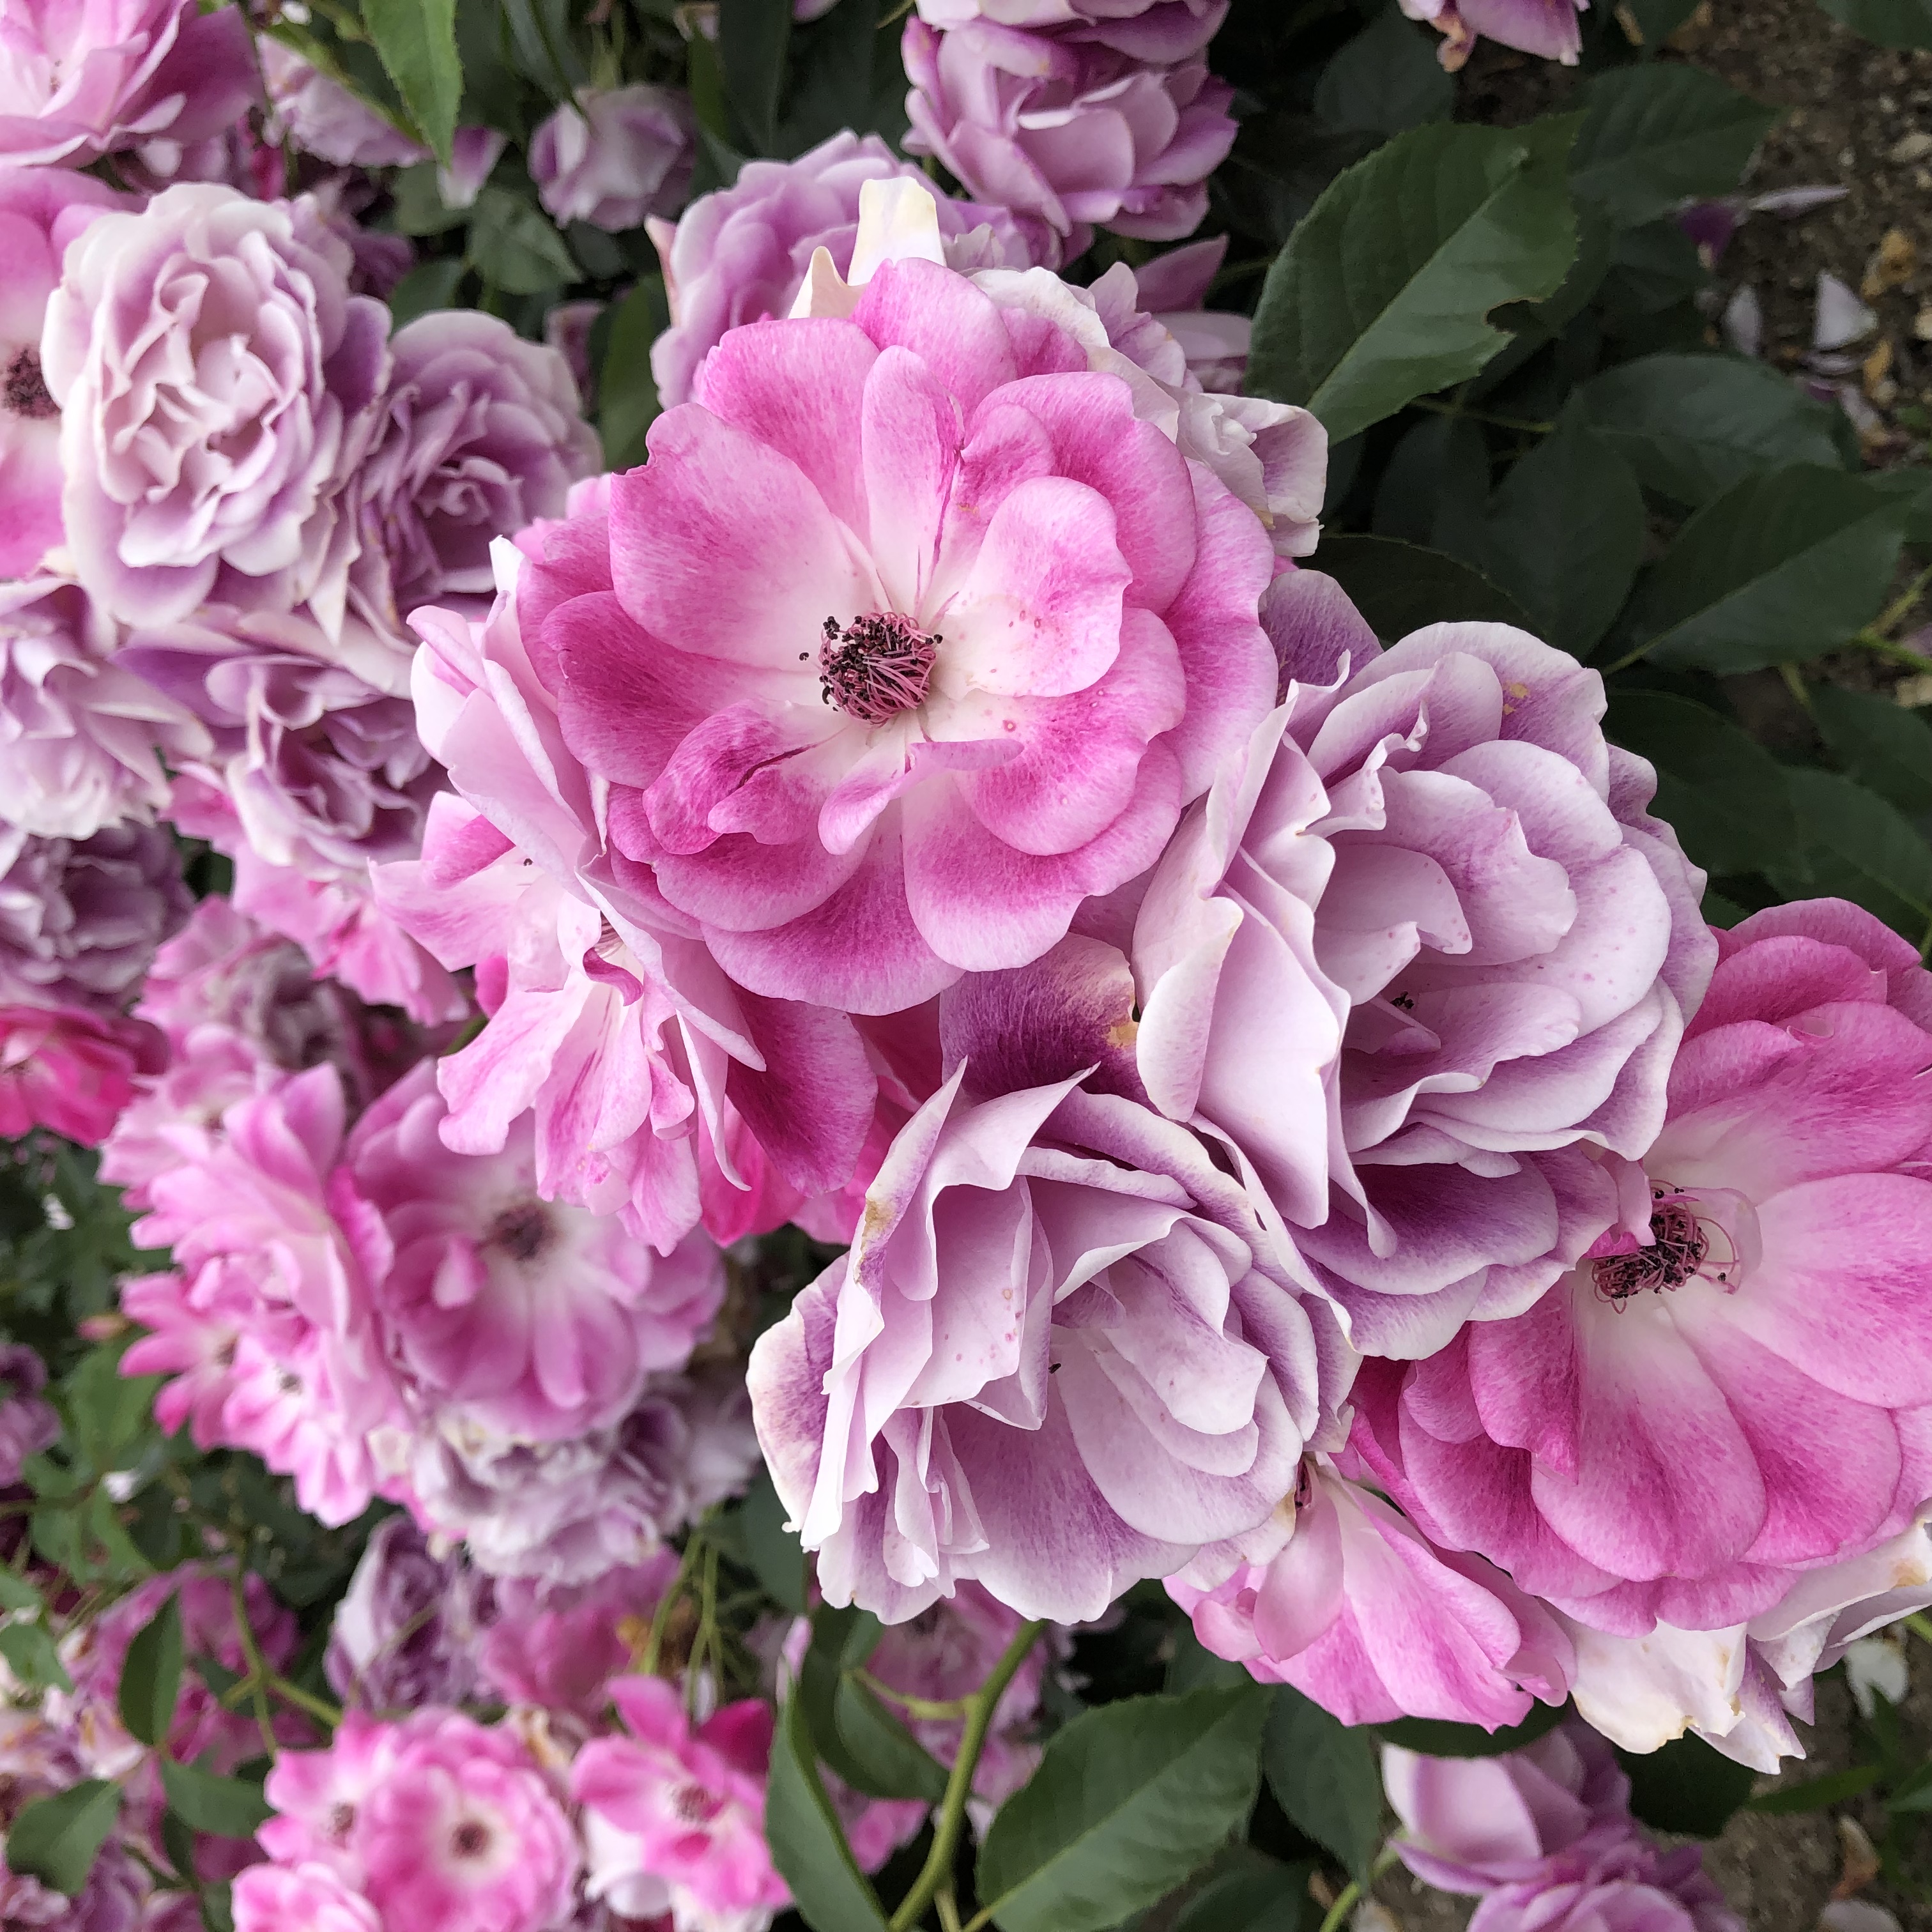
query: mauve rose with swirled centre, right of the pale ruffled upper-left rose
349 309 601 649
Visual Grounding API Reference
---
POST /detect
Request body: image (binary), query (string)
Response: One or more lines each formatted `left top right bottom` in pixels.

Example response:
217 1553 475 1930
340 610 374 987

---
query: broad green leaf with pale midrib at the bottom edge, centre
974 1685 1268 1932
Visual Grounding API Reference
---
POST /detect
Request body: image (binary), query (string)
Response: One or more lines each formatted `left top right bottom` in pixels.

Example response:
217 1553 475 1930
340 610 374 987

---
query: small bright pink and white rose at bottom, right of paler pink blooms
570 1677 790 1919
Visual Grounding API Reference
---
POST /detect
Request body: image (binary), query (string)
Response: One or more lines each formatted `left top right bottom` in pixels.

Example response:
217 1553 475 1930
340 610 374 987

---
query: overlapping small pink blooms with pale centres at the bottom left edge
257 1706 578 1932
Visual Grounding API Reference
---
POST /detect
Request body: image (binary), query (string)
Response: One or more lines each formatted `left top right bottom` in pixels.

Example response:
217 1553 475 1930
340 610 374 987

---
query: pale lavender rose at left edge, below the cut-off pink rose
0 576 209 838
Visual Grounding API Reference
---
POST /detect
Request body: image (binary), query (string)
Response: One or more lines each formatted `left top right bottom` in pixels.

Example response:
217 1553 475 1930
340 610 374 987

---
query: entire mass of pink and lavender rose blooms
0 0 1908 1932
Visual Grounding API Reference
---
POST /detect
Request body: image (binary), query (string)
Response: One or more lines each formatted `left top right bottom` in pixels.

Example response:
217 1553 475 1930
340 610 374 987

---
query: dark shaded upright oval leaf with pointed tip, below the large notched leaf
1482 411 1644 657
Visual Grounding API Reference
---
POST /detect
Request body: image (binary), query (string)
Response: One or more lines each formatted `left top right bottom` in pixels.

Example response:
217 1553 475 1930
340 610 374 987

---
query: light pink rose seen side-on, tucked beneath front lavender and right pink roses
1167 1459 1573 1731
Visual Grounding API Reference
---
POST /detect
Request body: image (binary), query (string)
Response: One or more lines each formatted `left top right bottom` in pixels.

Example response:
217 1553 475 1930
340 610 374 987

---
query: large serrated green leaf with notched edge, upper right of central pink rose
1248 118 1577 440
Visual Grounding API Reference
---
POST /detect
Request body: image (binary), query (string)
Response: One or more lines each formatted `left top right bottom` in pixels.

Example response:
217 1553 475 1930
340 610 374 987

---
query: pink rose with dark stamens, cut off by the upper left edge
0 167 139 578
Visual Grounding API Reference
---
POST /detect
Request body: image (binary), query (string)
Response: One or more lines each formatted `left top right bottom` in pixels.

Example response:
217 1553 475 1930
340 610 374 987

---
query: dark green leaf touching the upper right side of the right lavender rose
1606 690 1798 877
